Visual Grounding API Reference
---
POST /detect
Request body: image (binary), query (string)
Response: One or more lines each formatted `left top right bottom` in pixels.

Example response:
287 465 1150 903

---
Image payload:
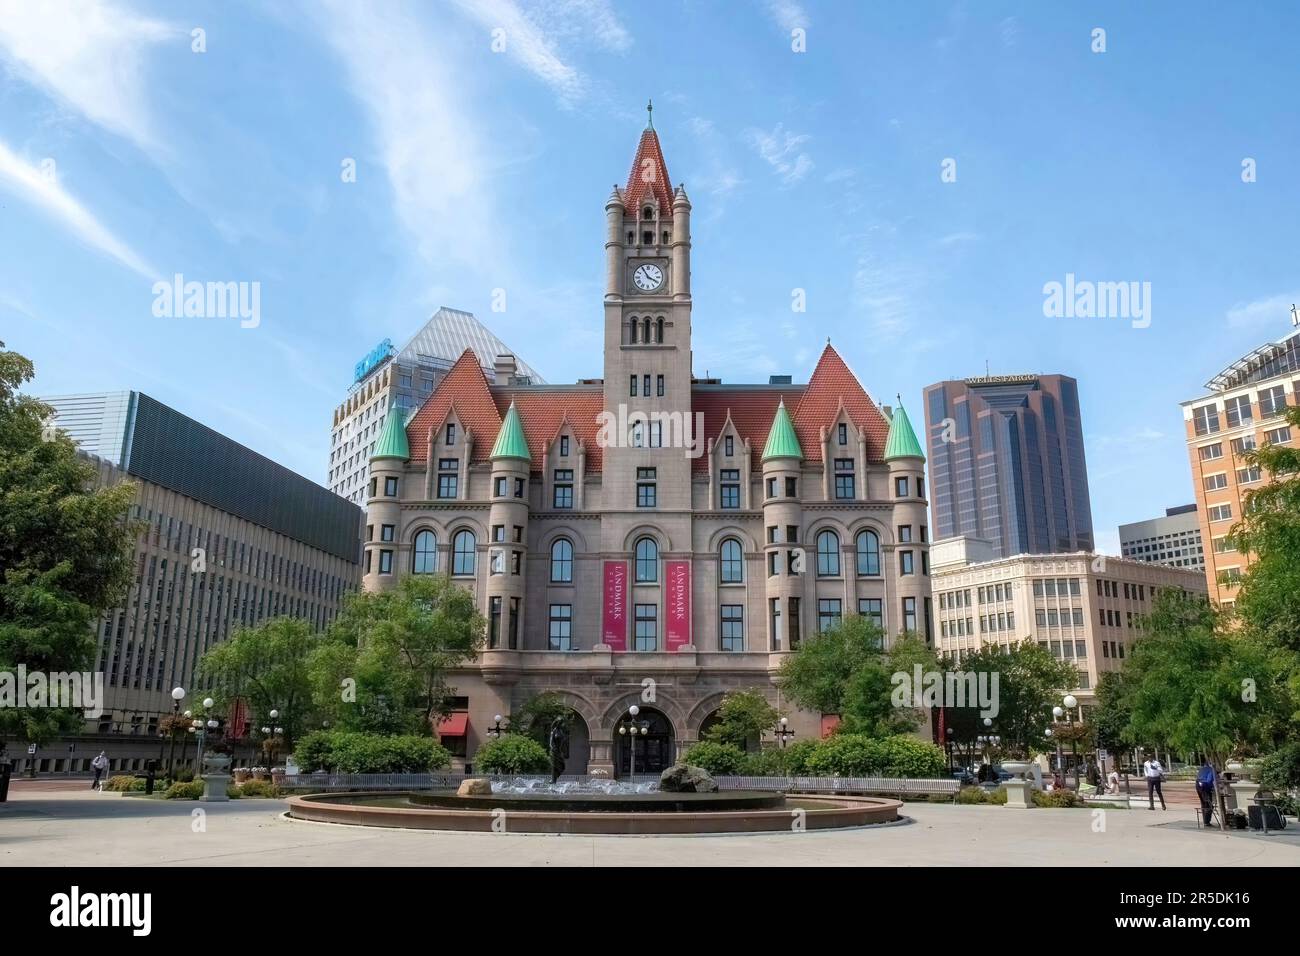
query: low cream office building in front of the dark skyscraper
931 537 1205 706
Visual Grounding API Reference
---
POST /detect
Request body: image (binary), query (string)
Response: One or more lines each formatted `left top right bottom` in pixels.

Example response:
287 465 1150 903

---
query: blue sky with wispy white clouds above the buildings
0 0 1300 549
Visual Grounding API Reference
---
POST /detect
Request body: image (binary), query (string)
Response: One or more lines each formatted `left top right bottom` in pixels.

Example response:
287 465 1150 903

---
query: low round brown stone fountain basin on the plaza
289 791 902 835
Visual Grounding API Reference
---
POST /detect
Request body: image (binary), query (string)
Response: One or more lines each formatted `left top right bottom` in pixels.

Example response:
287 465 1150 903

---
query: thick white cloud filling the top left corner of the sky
0 0 175 150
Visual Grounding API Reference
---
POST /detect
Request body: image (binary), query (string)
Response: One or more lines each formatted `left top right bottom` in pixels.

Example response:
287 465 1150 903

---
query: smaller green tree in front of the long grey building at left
196 618 321 749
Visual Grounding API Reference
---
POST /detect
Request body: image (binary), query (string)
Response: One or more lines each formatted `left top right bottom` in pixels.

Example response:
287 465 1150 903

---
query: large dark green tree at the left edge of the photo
0 342 138 744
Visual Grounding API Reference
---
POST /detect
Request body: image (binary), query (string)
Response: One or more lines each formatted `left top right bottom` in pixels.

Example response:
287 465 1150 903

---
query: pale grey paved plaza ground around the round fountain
0 786 1300 866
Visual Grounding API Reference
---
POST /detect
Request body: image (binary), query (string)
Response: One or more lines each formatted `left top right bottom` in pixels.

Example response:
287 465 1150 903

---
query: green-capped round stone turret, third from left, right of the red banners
763 398 815 652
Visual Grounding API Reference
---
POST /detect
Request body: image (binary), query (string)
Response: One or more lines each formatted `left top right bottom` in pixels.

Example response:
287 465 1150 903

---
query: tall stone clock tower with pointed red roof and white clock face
603 105 703 511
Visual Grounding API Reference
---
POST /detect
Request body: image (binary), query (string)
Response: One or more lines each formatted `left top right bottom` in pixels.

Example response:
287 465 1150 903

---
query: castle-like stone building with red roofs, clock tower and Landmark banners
363 117 931 774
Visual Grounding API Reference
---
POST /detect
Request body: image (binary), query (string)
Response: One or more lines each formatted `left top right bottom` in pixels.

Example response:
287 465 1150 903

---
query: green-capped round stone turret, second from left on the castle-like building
485 402 532 650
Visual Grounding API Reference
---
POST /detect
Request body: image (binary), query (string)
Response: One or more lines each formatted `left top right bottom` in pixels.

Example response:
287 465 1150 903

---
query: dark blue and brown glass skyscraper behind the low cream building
926 375 1095 558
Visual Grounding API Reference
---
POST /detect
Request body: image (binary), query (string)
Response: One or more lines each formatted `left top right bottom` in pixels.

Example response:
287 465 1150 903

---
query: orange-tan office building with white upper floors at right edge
1182 307 1300 606
